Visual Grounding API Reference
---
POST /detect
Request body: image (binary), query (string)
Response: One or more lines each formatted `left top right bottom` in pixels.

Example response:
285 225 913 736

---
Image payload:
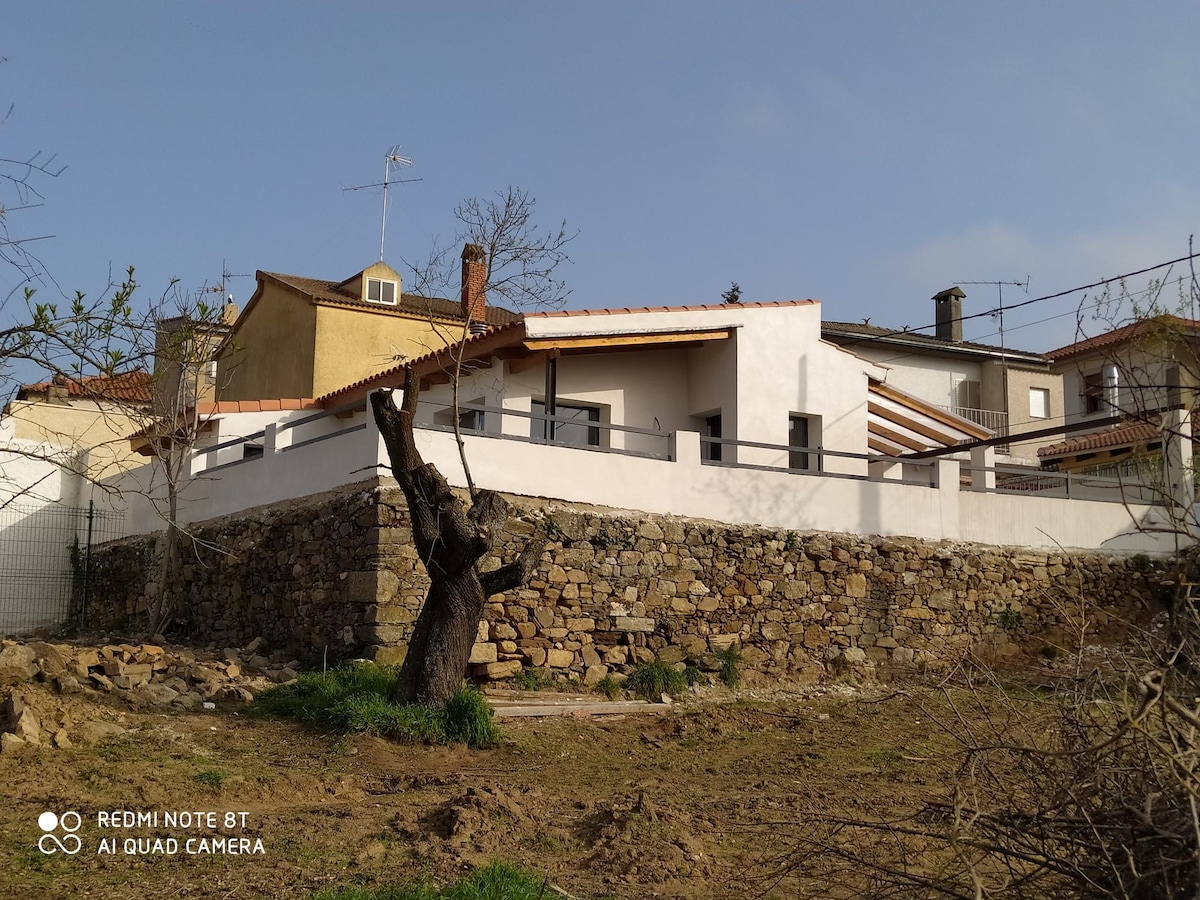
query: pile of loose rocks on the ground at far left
0 638 300 752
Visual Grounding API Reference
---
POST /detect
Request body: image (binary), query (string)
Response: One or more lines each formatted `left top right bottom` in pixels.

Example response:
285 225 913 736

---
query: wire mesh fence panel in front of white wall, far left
0 503 124 636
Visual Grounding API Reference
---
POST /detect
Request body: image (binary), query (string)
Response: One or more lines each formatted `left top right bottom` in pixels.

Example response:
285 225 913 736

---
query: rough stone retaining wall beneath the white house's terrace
91 482 1157 682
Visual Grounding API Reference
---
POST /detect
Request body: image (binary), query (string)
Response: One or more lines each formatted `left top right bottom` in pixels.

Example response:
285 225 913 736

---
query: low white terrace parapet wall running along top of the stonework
97 405 1169 551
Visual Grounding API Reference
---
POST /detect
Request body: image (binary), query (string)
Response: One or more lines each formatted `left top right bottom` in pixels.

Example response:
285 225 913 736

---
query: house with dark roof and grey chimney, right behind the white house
821 287 1063 462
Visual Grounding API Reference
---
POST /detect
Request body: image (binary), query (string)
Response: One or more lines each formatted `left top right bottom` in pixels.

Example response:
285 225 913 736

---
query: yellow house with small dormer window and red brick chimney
217 247 517 400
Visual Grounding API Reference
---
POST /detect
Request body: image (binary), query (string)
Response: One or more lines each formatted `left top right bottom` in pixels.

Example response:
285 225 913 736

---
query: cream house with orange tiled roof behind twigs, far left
4 370 152 479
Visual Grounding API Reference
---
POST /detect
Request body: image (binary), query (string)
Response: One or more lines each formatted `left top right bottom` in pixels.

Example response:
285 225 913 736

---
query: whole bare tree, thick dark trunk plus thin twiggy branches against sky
371 187 575 703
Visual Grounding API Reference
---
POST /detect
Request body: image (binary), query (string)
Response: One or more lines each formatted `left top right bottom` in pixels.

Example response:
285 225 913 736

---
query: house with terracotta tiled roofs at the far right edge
1038 314 1200 475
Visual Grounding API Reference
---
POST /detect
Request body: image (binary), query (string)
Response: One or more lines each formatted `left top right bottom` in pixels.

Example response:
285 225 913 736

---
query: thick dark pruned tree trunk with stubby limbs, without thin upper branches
371 368 545 703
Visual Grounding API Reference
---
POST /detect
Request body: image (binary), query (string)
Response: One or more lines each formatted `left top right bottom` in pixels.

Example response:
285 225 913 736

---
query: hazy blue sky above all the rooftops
0 0 1200 350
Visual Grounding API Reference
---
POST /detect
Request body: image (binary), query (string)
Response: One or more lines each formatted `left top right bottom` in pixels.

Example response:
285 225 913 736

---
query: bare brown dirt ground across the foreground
0 684 1012 900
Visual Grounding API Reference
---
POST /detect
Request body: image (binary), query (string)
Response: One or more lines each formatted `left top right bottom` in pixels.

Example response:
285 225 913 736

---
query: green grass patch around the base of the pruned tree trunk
256 662 499 748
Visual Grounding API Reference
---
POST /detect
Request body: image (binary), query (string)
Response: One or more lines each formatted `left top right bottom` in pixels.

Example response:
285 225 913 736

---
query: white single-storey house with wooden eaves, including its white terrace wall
88 300 1176 548
